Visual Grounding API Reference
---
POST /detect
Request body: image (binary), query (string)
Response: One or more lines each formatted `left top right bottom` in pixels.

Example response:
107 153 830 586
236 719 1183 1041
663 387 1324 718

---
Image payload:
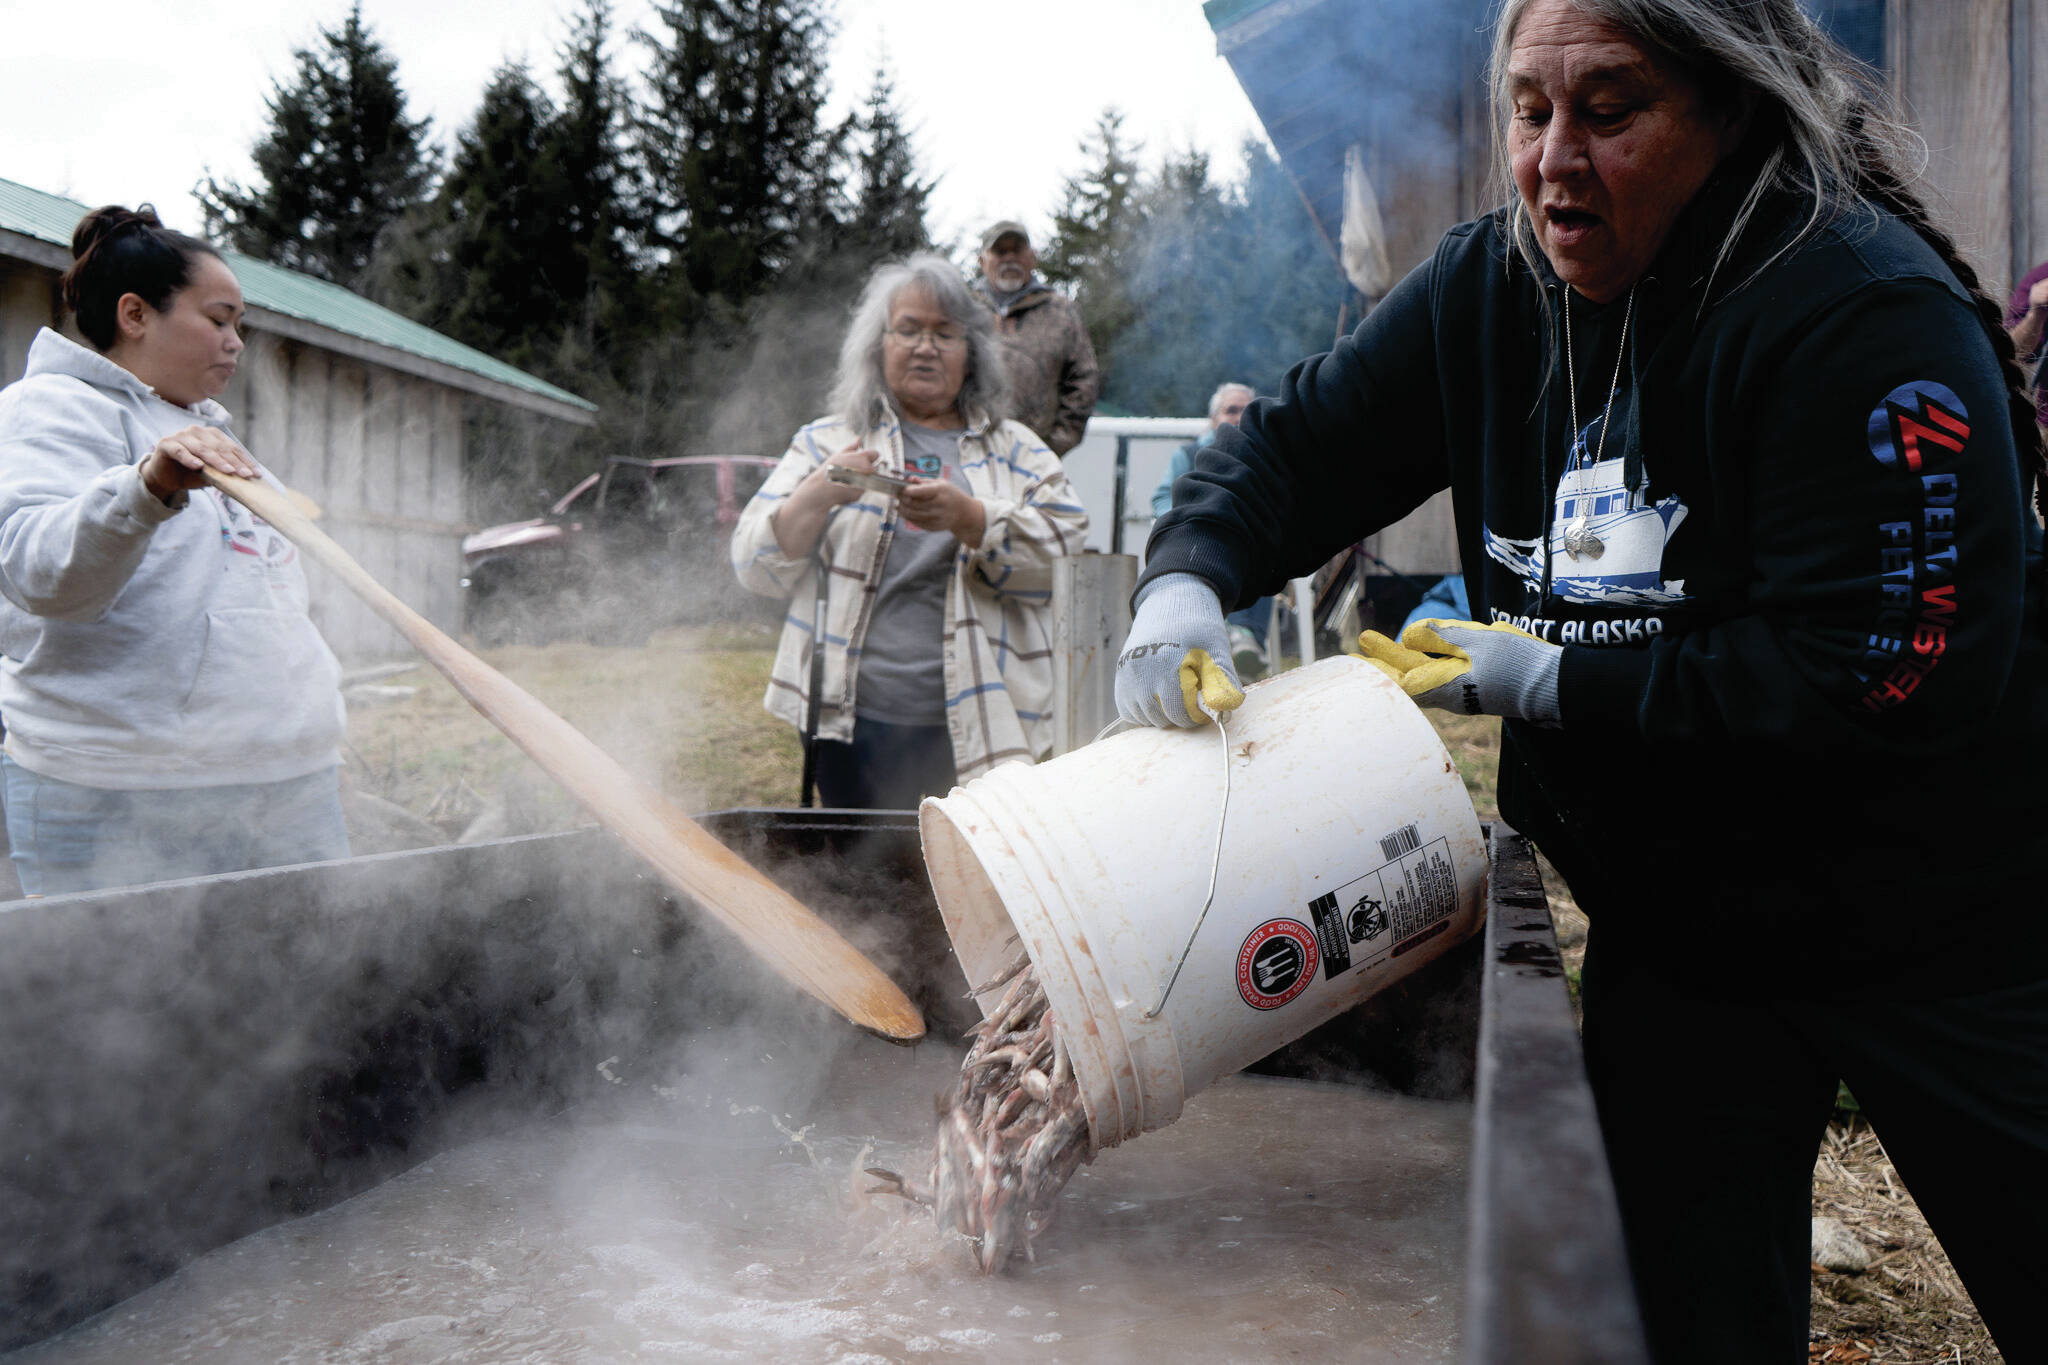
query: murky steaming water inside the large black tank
8 1040 1470 1365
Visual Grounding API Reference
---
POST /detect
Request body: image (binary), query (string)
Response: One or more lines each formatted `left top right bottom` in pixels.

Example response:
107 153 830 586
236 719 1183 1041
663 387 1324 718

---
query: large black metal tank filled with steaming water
0 810 1640 1363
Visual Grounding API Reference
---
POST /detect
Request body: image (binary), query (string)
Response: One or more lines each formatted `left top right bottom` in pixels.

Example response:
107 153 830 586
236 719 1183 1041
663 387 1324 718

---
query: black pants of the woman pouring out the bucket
1583 927 2048 1365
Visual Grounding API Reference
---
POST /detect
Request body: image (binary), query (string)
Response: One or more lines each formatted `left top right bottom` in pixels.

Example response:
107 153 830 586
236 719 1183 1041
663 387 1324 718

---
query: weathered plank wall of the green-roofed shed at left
0 260 469 663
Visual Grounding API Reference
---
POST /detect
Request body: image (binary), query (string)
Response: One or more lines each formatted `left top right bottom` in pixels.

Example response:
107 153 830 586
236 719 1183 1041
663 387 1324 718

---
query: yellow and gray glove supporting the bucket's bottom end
1358 620 1565 724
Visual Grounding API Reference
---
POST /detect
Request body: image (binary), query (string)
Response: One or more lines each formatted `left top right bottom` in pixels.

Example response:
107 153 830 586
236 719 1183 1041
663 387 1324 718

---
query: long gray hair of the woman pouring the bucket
1487 0 2042 487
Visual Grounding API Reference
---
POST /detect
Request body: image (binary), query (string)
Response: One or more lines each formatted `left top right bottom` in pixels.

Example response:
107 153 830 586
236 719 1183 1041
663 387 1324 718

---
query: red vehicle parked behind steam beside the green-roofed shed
463 454 782 645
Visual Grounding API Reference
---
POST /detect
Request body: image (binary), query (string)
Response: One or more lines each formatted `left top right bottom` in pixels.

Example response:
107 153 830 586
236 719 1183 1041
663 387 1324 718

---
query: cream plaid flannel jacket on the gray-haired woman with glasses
731 413 1087 782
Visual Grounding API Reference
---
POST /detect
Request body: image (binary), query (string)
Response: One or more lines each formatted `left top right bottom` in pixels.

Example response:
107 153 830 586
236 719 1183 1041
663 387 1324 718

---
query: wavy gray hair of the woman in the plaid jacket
831 252 1010 432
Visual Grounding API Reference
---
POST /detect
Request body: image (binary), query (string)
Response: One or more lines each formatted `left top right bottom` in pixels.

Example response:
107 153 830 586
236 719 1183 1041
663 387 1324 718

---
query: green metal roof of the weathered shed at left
0 180 598 424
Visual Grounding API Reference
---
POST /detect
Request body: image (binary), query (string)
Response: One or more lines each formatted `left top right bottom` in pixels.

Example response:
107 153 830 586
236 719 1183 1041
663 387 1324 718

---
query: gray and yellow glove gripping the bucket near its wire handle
1116 573 1245 731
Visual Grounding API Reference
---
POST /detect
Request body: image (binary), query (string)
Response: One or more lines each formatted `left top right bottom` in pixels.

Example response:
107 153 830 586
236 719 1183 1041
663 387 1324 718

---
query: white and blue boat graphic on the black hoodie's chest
1483 417 1686 606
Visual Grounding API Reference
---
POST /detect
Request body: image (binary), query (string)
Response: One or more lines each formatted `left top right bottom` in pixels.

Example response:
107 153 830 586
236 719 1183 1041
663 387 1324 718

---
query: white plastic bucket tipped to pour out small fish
918 657 1487 1148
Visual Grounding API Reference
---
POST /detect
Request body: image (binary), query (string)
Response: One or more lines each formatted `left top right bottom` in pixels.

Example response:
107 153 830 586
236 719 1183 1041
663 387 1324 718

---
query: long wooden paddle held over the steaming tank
205 469 924 1044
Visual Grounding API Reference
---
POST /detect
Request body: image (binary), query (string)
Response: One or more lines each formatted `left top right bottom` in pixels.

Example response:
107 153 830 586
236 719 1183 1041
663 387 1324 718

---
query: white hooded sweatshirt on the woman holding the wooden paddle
0 327 342 790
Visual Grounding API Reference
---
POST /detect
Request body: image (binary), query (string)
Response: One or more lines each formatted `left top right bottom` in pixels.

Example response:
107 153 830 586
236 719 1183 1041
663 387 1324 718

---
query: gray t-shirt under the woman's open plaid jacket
854 422 967 724
